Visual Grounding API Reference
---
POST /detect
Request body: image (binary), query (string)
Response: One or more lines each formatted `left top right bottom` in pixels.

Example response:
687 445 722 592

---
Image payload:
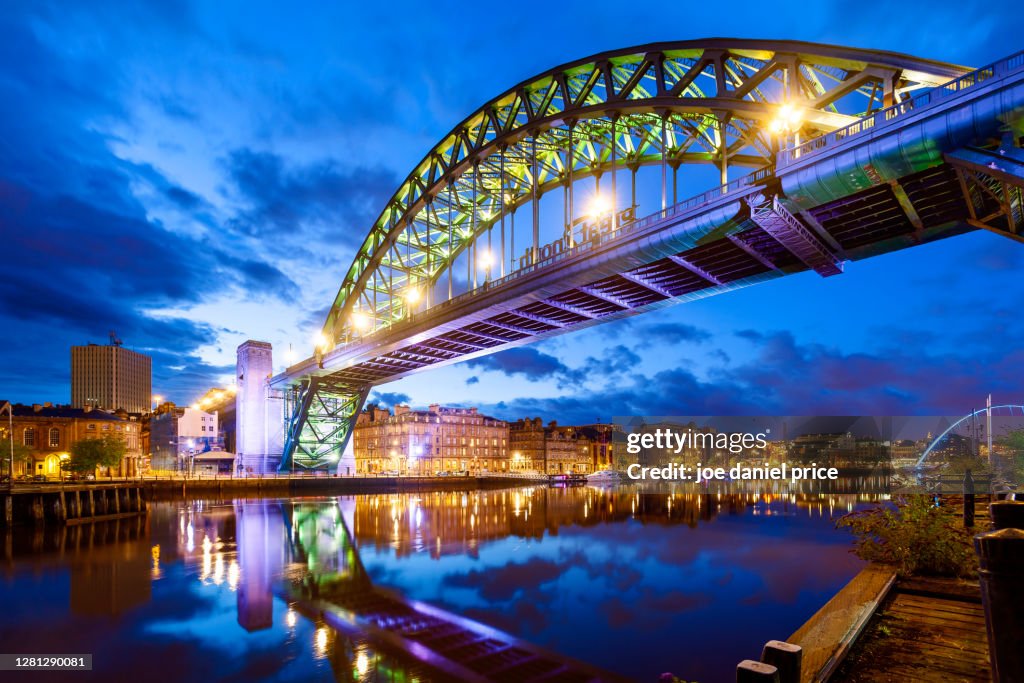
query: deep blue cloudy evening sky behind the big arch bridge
0 0 1024 422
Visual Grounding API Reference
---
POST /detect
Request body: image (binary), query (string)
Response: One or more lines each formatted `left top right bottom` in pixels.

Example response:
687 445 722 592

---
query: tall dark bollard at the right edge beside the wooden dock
974 528 1024 683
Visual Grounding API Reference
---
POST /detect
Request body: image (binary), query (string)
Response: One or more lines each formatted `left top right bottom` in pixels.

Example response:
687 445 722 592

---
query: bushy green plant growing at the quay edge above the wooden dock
837 496 977 577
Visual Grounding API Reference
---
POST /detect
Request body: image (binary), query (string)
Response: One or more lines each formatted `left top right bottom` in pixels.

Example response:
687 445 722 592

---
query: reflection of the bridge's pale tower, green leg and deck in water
266 495 620 682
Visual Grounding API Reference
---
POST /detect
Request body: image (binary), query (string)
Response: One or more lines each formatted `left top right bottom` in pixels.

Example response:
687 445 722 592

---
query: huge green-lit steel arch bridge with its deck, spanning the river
260 39 1024 469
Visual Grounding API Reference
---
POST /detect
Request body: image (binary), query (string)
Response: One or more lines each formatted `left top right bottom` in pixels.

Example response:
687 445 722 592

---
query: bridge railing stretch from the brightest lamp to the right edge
776 50 1024 166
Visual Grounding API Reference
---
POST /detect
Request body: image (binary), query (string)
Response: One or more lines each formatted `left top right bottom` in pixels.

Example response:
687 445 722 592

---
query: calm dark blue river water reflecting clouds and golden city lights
0 487 880 683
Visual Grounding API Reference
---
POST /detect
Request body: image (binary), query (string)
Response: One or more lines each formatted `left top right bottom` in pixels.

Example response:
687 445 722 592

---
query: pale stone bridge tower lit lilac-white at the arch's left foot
234 340 285 473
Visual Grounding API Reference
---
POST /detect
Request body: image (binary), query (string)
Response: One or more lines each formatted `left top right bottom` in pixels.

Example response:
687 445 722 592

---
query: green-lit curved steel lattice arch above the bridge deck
323 39 968 350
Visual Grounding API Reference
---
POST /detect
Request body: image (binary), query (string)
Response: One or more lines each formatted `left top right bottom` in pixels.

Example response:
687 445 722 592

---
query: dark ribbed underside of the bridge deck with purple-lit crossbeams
315 164 970 389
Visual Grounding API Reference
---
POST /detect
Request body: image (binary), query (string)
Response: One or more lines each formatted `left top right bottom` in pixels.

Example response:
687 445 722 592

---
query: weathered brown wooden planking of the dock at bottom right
830 579 989 683
